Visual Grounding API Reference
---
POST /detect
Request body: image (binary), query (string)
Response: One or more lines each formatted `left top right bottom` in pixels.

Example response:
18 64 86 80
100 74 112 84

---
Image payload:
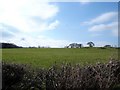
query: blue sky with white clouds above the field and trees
0 0 118 48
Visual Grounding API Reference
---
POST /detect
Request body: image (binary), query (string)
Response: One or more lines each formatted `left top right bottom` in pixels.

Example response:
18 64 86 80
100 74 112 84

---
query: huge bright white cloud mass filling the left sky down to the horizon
0 0 62 47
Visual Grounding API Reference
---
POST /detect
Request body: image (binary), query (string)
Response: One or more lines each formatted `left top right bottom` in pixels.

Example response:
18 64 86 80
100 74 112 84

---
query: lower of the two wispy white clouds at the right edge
89 22 118 36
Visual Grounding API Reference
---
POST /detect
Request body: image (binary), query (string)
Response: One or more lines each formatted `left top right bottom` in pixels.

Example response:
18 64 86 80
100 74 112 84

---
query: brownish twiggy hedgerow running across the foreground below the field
2 60 120 90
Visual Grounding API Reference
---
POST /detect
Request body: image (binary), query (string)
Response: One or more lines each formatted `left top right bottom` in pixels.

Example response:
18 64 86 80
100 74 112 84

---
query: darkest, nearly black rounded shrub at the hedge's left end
2 63 25 90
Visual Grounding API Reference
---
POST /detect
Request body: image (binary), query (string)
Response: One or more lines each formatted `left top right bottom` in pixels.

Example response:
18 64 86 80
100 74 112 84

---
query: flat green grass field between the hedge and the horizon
2 48 118 67
